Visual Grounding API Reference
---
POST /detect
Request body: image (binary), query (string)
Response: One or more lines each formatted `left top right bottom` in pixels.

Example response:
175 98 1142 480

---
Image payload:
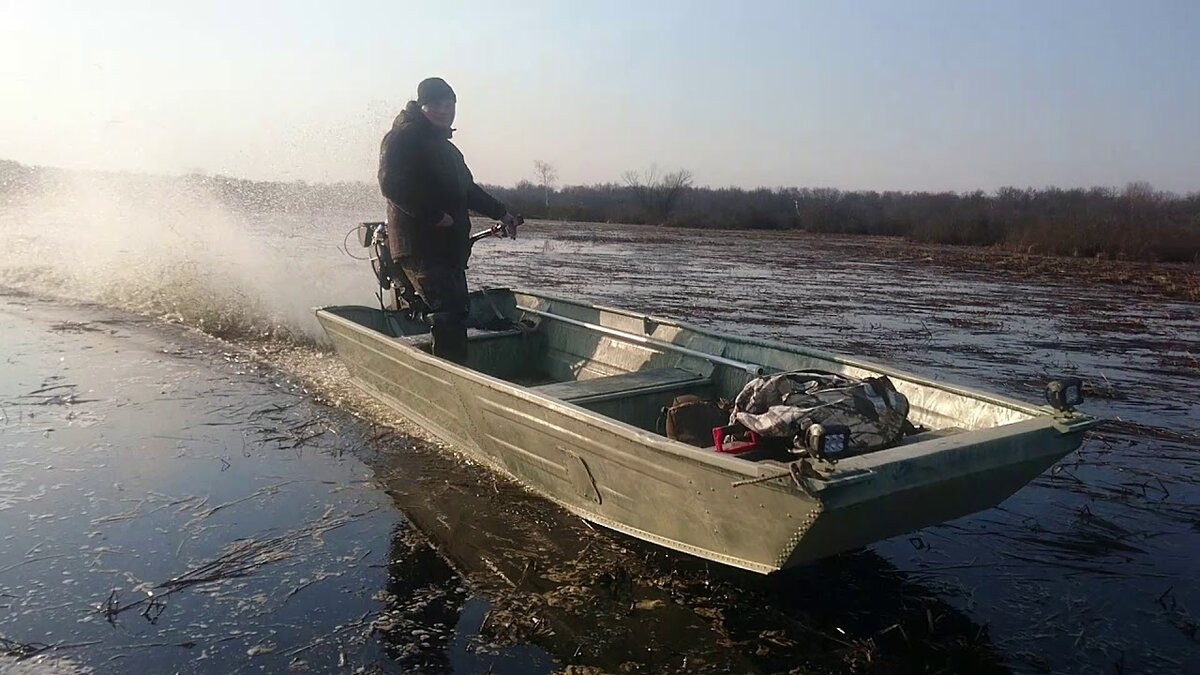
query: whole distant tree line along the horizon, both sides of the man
0 161 1200 263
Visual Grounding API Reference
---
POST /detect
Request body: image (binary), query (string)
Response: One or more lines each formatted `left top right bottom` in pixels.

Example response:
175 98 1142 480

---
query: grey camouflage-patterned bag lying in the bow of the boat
732 370 912 453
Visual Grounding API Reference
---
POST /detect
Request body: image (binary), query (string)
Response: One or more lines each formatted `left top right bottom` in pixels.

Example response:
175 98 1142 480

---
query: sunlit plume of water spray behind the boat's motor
0 173 366 342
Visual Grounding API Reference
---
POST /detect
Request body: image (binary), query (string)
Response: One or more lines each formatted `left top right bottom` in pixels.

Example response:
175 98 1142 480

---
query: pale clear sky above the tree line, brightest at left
0 0 1200 192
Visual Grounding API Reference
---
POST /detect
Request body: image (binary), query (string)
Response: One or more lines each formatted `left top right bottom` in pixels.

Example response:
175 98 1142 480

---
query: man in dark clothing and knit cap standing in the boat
379 77 516 364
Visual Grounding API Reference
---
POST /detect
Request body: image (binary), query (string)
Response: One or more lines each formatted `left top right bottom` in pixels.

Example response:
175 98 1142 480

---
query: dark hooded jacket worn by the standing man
379 101 508 269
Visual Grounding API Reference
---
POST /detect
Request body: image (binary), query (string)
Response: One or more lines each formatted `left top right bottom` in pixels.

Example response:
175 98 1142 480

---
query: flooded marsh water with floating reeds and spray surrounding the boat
0 186 1200 673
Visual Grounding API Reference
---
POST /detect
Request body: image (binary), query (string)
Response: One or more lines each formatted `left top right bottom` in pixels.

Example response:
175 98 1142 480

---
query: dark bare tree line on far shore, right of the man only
490 172 1200 262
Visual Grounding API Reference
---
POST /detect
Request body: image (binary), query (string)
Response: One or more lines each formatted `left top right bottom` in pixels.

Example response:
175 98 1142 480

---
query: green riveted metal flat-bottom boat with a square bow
317 289 1096 573
